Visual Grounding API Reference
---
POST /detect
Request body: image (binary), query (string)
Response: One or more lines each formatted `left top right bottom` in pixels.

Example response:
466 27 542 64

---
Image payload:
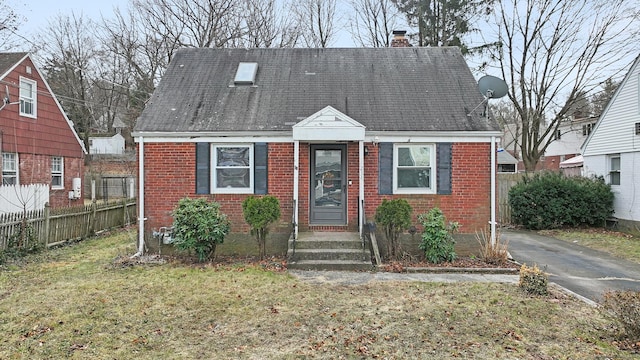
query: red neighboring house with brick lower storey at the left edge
0 53 86 207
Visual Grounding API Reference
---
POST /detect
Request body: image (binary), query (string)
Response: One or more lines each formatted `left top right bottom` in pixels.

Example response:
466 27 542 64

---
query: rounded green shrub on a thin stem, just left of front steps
242 195 280 260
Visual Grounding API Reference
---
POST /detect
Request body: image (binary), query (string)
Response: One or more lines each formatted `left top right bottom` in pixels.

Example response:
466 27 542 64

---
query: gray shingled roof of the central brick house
134 47 499 132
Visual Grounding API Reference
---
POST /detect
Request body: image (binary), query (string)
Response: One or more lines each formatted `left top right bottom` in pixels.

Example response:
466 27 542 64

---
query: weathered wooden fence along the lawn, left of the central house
0 199 136 250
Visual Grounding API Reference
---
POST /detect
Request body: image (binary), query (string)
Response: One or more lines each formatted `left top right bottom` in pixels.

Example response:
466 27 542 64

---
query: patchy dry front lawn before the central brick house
0 232 635 359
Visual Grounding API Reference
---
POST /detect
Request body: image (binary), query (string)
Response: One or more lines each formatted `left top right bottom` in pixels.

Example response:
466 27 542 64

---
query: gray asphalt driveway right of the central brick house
501 230 640 302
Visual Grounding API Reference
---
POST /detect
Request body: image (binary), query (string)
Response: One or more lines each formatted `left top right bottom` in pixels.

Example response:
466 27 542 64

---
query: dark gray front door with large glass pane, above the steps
309 144 347 225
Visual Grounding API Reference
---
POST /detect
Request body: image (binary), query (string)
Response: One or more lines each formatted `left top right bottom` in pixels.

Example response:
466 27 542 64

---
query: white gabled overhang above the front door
293 106 365 141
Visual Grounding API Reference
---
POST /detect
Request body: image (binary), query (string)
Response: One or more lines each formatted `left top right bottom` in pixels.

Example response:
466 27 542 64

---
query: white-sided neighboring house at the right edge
582 56 640 231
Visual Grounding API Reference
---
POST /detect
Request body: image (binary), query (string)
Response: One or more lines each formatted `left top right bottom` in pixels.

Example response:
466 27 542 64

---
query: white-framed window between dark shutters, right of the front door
393 144 436 194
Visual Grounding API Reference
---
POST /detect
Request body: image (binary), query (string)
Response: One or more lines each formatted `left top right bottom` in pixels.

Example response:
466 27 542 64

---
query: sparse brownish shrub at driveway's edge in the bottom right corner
600 290 640 342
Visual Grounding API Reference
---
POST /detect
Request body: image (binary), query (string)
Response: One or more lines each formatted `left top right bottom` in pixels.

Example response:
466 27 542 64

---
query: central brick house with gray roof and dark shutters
133 47 501 258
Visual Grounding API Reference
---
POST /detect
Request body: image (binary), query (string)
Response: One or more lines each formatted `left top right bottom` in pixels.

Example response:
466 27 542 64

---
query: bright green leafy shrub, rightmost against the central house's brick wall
418 208 459 264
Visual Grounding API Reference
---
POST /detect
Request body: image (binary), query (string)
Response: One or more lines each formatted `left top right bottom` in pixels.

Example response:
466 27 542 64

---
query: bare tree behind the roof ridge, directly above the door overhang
293 0 339 48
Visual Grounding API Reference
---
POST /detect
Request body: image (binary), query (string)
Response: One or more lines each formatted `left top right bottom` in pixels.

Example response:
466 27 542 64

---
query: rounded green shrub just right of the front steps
375 199 413 259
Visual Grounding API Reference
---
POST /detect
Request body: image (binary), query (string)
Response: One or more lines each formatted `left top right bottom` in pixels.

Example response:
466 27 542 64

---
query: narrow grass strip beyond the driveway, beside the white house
540 228 640 264
